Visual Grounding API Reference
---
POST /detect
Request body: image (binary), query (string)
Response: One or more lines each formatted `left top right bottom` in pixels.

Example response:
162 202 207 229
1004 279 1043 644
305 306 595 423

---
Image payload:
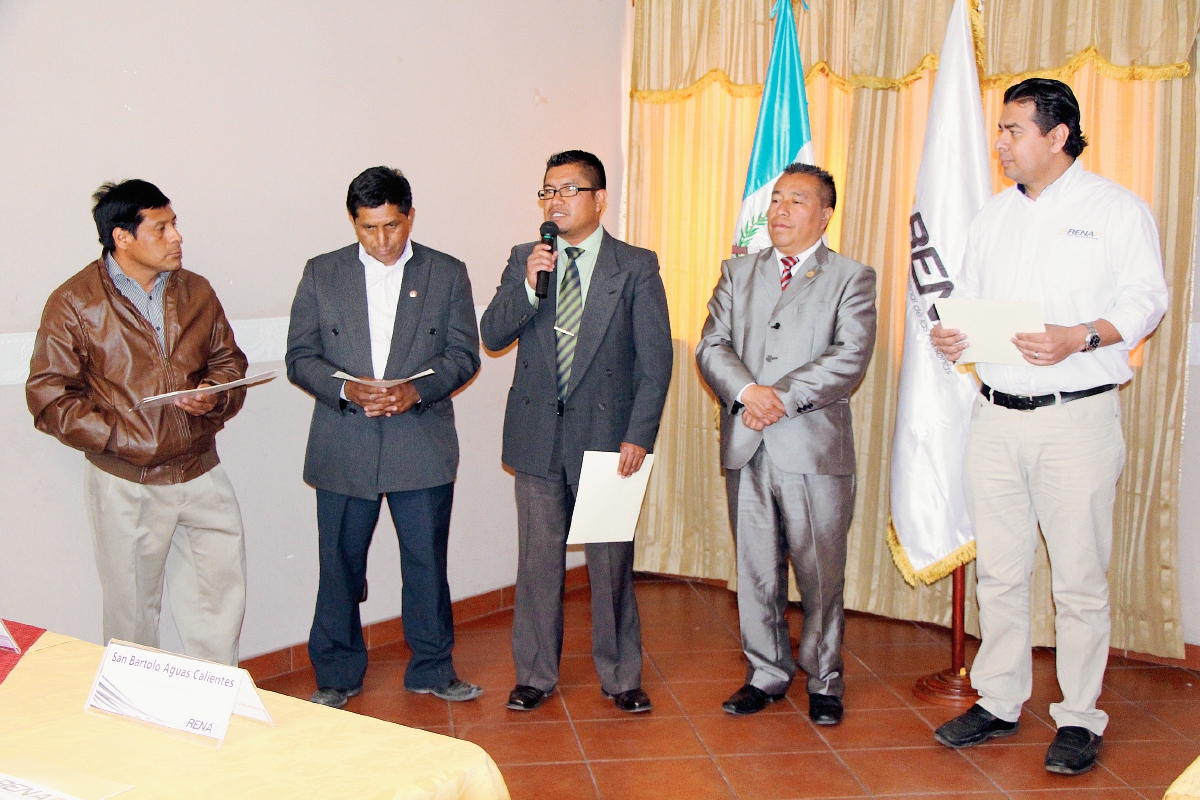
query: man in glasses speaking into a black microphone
480 150 672 714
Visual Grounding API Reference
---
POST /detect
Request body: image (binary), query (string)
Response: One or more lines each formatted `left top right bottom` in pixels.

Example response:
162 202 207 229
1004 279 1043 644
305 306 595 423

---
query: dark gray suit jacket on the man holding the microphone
480 227 674 483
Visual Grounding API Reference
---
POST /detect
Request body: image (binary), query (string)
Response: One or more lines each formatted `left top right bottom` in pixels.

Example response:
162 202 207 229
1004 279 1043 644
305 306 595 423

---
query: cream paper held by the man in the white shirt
934 297 1046 367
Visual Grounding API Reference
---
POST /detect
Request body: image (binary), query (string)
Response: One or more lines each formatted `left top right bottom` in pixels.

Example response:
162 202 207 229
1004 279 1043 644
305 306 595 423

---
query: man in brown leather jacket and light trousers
25 180 246 664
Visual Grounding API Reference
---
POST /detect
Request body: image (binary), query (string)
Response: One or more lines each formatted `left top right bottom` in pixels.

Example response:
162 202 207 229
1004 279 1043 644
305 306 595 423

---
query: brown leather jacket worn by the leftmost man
25 257 246 485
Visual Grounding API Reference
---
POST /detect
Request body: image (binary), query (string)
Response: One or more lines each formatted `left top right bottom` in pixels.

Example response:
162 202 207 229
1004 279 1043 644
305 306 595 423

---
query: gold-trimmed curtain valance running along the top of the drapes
632 0 1200 94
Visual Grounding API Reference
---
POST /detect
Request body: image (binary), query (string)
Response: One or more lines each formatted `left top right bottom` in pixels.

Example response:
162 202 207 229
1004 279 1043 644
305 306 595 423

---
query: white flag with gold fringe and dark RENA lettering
888 0 991 585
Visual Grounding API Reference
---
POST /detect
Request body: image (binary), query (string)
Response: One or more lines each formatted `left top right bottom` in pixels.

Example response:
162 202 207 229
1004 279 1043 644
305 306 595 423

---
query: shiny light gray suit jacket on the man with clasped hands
696 245 876 475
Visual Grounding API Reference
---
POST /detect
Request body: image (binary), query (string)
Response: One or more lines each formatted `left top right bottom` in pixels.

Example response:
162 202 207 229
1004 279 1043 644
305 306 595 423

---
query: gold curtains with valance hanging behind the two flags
628 0 1200 657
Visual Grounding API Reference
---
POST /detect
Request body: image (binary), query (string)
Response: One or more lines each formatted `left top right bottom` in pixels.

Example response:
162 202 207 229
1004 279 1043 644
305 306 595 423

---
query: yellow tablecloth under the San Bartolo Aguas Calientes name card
0 633 509 800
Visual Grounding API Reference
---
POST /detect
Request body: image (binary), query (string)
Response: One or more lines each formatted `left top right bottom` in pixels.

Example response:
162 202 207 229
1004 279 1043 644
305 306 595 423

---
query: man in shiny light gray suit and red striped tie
696 164 876 724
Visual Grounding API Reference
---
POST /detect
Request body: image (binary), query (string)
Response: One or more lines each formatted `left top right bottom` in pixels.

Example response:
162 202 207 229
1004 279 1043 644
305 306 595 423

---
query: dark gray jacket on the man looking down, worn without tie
284 242 479 499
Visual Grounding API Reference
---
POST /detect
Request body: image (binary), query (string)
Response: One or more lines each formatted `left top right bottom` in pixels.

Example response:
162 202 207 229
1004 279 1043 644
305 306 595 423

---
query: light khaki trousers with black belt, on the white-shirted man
965 391 1126 734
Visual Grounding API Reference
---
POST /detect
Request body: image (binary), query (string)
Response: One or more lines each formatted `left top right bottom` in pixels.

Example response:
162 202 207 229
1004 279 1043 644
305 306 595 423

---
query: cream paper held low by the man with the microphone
566 450 654 545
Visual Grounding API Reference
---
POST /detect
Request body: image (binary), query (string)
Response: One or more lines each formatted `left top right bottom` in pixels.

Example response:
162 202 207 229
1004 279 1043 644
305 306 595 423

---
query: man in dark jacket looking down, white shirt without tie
286 167 482 708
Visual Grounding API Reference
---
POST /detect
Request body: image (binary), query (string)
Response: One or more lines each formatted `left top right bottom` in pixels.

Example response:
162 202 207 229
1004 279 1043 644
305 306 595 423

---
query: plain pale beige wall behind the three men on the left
0 0 629 656
